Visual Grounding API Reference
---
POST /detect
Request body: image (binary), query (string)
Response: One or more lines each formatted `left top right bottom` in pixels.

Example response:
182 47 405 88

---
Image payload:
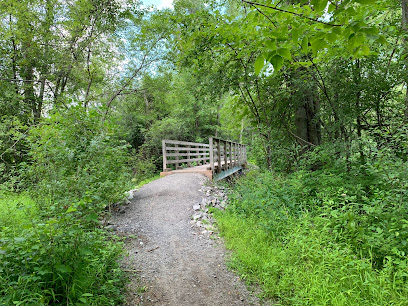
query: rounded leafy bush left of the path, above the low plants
27 106 130 212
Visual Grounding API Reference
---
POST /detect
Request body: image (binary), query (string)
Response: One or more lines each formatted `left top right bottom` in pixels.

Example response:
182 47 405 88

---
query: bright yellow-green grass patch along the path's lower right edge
216 210 408 305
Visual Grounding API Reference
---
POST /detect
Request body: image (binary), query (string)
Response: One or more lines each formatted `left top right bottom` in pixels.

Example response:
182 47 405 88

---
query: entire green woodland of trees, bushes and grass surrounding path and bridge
0 0 408 305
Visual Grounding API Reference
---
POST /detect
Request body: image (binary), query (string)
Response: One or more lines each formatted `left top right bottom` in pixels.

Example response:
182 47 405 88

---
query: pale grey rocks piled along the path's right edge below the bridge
190 186 228 235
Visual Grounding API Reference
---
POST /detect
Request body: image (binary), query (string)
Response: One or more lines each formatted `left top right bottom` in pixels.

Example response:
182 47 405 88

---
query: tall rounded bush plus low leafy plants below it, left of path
0 106 131 305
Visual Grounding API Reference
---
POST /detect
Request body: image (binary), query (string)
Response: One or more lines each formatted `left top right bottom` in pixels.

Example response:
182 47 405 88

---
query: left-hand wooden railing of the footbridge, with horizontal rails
162 140 210 171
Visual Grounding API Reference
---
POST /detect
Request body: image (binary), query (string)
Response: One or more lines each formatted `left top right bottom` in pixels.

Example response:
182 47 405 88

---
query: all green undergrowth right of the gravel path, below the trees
216 153 408 305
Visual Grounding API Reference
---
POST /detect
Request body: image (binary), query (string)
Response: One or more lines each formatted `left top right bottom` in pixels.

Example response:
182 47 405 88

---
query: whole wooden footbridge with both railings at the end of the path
160 137 247 181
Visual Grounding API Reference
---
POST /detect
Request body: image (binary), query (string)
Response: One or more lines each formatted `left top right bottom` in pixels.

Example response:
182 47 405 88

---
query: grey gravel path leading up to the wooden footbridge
112 173 257 306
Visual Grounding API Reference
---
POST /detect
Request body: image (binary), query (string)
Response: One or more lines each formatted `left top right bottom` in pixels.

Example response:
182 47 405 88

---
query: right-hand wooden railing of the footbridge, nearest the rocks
210 137 247 174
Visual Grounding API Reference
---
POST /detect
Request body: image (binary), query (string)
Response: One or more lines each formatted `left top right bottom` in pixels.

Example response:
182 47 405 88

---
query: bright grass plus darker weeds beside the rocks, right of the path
216 174 408 305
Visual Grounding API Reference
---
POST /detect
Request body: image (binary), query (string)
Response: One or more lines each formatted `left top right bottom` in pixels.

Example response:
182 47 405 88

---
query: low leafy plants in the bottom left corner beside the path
0 195 124 305
